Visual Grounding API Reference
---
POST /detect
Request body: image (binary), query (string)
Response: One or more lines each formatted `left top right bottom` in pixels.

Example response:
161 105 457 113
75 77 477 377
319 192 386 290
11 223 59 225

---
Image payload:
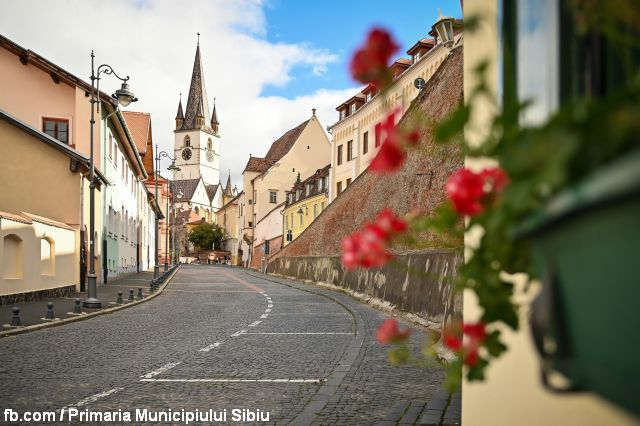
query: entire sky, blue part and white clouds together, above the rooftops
0 0 462 189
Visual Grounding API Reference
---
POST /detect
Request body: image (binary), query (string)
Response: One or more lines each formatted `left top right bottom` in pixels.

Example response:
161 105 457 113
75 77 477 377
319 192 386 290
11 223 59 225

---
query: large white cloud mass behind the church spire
0 0 355 186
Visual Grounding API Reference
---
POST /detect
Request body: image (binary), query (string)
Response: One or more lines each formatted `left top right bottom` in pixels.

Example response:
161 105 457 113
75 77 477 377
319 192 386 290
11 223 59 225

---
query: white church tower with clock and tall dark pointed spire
174 34 220 185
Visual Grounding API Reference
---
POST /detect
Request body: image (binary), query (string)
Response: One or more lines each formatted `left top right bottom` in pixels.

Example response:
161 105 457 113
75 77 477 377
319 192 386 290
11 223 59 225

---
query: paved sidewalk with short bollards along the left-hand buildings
0 268 156 332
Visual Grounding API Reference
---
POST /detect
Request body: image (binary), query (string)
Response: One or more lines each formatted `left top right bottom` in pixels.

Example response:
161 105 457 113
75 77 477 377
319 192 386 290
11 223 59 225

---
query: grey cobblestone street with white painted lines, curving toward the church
0 265 444 425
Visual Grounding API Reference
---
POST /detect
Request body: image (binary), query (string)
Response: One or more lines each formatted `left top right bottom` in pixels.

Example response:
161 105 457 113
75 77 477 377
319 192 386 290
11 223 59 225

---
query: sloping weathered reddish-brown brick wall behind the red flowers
268 48 464 324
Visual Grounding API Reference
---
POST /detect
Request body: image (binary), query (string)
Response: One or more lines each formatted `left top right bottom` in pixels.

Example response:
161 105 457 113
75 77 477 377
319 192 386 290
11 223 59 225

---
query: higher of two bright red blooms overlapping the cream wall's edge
445 168 509 216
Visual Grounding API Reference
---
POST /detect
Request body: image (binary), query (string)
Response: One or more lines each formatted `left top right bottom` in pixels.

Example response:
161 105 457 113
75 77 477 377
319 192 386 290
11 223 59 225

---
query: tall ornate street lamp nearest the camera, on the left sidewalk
83 50 138 308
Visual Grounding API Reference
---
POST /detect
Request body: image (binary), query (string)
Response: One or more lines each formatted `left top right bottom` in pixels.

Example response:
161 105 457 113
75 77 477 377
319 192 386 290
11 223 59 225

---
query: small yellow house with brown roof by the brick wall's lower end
282 164 331 246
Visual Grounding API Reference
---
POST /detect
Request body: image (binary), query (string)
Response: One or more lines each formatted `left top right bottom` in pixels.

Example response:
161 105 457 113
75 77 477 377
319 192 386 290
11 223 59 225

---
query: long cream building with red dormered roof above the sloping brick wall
329 22 461 200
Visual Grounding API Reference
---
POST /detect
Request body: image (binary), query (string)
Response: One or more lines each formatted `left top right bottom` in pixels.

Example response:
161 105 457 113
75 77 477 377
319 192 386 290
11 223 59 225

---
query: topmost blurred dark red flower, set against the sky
350 28 399 87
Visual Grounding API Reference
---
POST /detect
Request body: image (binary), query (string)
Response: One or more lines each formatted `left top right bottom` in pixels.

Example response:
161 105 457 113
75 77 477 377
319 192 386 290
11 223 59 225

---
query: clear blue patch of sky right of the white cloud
261 0 462 98
